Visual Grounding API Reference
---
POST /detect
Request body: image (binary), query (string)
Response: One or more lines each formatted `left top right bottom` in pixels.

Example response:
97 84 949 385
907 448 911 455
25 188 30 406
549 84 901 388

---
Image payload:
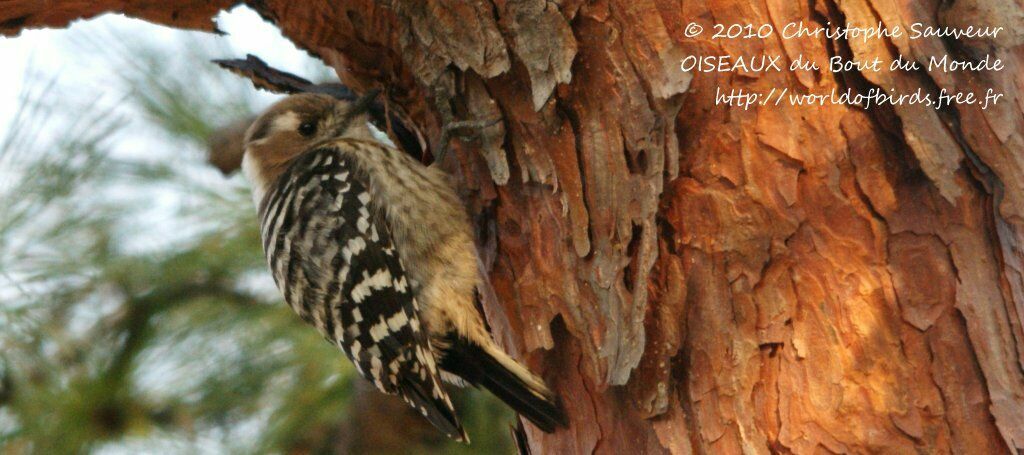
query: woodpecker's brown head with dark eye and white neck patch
242 90 377 198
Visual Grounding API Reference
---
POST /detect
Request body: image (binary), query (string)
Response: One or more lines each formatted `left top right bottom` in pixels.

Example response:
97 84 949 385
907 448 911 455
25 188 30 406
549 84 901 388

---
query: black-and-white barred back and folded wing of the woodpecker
259 141 464 439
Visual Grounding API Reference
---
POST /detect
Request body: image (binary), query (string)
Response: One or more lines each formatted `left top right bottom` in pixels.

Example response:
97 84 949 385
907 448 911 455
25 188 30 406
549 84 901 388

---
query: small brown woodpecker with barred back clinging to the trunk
242 89 567 442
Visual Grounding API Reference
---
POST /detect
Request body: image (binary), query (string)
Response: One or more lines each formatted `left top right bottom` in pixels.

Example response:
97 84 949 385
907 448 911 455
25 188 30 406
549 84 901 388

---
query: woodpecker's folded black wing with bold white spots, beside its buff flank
282 141 465 440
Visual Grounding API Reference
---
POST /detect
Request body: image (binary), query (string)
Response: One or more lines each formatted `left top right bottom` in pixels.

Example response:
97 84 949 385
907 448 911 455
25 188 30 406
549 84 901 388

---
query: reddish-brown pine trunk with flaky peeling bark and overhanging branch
0 0 1024 453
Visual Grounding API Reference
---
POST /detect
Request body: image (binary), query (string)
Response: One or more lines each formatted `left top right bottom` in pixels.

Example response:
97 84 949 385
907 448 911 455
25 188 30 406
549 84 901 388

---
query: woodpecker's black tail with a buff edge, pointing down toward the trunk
440 335 568 432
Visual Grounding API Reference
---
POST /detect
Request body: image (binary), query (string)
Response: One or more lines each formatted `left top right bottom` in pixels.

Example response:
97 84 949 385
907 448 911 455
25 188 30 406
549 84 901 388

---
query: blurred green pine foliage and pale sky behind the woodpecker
0 8 513 454
